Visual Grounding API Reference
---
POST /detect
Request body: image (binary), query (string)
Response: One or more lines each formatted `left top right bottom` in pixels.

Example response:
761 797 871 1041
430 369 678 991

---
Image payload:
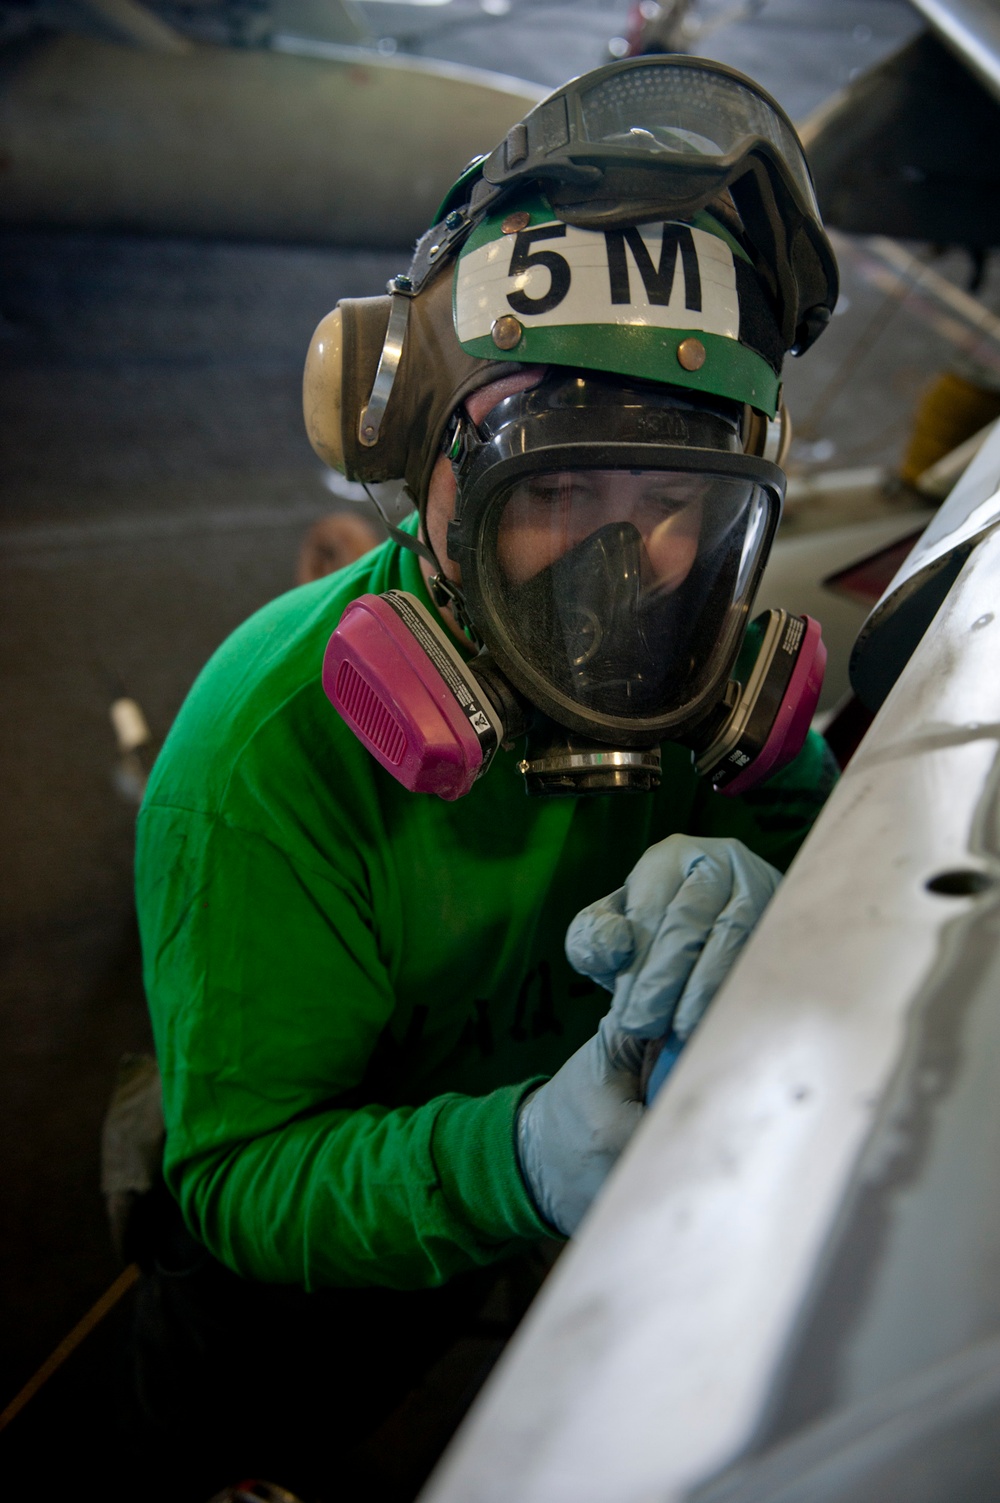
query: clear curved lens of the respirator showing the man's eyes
489 469 770 721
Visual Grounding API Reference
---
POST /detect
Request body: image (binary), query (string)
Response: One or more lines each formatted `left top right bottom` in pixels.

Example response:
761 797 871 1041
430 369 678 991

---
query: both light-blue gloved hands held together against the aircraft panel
517 836 780 1235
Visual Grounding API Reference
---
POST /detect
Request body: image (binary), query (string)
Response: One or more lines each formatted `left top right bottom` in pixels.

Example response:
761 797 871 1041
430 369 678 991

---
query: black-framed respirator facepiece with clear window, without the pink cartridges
448 373 783 747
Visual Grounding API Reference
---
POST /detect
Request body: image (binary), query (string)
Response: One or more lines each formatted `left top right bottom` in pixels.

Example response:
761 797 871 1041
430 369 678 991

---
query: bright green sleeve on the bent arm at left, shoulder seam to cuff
137 806 547 1288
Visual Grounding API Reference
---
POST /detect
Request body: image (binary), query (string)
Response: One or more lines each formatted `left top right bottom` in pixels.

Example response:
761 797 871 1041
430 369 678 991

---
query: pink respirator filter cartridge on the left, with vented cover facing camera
323 589 504 800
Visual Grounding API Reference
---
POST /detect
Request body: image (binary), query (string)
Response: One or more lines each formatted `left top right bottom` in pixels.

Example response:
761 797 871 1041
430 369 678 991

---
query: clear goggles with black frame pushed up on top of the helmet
466 56 838 352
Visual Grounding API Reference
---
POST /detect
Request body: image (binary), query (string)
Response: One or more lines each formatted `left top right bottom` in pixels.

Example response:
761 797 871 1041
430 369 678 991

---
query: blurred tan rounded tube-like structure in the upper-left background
0 30 543 246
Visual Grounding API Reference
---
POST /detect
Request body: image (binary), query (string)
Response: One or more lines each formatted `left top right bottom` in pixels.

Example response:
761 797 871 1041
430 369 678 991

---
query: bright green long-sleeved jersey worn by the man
137 529 835 1288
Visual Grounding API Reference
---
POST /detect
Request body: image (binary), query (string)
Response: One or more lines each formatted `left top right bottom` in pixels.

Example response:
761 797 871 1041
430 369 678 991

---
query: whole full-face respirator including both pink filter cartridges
323 371 826 800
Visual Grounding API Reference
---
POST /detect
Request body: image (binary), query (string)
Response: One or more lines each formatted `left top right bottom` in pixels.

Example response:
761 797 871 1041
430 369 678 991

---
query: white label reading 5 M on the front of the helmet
454 219 740 344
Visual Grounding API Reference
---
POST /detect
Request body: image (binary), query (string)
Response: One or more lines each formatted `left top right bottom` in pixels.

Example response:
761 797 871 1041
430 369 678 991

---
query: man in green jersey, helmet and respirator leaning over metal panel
130 59 836 1485
